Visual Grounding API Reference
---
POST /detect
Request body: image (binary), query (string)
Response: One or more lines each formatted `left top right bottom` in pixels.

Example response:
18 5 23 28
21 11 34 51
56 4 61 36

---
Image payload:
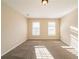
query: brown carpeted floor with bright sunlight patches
1 41 78 59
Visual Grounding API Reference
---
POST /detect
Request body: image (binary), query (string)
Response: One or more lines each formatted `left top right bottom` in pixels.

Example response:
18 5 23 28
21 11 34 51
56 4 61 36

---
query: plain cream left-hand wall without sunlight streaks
1 2 27 55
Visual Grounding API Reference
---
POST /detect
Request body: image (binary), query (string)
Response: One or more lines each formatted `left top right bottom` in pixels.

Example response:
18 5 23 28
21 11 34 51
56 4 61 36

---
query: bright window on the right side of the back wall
48 22 56 36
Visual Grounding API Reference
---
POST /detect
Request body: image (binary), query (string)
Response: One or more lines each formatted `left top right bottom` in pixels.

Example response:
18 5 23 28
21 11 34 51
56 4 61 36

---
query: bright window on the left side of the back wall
32 22 40 35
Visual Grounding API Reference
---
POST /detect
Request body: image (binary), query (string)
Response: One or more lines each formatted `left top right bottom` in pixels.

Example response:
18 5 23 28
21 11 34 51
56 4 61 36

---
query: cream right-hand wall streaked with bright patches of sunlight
60 9 78 50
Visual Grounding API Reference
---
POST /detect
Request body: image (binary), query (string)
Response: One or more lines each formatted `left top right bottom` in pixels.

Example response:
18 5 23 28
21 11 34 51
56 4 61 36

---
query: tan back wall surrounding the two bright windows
28 18 60 40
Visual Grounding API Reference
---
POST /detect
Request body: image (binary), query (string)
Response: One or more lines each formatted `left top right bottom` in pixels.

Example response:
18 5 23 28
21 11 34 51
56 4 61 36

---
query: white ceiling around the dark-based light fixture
2 0 77 18
